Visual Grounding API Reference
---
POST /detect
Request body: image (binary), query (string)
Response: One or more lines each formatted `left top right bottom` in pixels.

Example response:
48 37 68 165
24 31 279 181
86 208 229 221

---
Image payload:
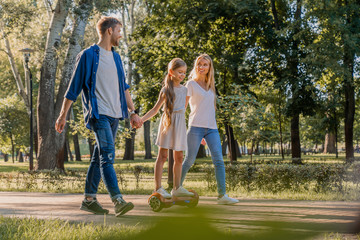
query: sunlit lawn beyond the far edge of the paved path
0 154 360 201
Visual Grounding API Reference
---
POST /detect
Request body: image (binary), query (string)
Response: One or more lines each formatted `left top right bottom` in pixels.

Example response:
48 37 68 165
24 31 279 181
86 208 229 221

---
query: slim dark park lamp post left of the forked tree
20 48 34 171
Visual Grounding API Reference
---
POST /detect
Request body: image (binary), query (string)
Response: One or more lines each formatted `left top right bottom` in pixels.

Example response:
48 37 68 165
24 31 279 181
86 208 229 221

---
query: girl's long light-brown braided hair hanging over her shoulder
163 58 186 131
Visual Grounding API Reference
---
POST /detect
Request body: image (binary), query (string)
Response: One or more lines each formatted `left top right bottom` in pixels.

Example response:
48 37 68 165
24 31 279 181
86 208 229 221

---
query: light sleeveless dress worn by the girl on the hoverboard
156 85 187 151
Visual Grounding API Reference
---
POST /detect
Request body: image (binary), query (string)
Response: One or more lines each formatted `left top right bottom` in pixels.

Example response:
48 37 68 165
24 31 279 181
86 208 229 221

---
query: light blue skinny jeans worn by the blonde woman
181 127 226 195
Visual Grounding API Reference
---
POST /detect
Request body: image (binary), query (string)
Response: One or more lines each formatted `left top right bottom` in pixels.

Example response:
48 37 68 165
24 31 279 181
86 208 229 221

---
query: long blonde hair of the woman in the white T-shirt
189 53 216 108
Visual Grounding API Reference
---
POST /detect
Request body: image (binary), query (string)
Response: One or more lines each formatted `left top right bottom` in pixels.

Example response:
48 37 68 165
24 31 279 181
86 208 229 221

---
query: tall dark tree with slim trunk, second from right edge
271 0 316 163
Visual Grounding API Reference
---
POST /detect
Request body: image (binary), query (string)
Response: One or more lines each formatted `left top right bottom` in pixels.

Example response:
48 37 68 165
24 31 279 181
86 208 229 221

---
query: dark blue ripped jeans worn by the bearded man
85 115 122 200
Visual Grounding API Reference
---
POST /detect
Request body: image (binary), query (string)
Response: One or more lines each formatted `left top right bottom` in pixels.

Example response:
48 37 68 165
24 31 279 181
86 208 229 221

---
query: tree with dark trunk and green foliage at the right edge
309 0 360 162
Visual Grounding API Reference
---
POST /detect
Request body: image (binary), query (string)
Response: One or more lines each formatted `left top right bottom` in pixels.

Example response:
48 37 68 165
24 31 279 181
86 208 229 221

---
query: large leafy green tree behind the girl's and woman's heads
133 0 266 160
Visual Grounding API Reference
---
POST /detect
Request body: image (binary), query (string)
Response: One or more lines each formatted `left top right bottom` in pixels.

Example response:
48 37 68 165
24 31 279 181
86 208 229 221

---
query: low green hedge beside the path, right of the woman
202 163 352 193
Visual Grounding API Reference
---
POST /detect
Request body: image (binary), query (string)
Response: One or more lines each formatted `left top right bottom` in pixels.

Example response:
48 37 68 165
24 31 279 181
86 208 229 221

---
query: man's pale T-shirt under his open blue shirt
95 46 122 118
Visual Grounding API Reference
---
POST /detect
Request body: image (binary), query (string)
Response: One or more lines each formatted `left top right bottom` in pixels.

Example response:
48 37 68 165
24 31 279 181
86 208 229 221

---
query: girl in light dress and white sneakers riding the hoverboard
142 58 194 198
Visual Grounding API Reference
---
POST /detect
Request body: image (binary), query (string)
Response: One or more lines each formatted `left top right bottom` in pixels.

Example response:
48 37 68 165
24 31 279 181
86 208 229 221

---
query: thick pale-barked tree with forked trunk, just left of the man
37 0 101 170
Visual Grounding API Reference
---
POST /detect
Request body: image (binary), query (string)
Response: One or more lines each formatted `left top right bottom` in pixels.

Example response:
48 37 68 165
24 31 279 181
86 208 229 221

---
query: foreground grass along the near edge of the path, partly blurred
0 215 360 240
